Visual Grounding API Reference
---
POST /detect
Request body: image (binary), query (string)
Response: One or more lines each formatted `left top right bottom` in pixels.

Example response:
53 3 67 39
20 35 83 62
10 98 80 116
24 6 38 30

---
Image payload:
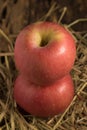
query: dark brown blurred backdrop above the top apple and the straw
0 0 87 34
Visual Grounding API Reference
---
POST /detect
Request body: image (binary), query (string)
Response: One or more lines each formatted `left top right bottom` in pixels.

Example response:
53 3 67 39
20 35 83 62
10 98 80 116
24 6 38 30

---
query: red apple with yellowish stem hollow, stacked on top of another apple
14 22 76 86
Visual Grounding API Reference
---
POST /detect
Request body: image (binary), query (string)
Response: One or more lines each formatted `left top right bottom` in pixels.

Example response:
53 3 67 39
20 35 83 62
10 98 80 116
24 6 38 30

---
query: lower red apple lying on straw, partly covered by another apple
13 74 74 117
